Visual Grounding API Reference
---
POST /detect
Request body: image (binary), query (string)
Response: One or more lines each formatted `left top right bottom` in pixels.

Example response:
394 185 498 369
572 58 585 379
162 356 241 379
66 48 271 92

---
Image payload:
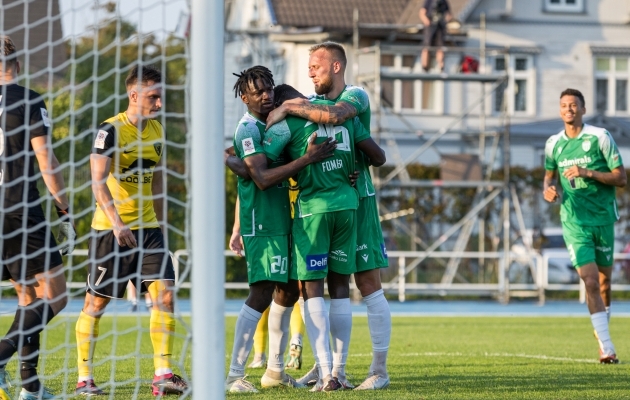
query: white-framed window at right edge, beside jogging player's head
594 56 630 115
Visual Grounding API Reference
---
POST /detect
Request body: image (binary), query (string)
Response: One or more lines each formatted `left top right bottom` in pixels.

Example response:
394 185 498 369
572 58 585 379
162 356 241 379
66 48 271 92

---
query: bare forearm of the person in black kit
31 136 69 210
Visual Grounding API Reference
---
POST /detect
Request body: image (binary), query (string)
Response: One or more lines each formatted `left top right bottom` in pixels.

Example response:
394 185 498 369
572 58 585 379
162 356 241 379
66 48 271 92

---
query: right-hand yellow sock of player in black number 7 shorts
149 310 175 376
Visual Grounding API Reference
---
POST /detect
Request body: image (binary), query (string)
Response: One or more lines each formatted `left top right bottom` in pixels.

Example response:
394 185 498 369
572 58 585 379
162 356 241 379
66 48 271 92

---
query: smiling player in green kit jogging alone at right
543 89 626 364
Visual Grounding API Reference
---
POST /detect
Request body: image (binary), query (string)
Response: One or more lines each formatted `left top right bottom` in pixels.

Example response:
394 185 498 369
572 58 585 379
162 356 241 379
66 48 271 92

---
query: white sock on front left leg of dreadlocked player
228 304 262 377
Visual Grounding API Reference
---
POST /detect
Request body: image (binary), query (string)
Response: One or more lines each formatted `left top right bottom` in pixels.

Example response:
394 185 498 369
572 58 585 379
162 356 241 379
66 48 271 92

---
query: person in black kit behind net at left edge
0 36 76 400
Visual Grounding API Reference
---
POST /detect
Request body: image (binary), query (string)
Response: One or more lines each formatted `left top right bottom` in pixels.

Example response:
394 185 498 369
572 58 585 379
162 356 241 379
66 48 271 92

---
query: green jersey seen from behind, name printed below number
263 101 370 218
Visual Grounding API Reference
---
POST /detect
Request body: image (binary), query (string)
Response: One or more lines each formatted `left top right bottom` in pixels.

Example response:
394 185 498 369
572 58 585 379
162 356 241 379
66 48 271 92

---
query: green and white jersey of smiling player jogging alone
545 125 623 226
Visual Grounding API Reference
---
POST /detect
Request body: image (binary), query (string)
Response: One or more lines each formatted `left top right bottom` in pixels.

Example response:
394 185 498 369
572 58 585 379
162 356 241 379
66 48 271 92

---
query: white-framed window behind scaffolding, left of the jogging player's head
490 55 536 115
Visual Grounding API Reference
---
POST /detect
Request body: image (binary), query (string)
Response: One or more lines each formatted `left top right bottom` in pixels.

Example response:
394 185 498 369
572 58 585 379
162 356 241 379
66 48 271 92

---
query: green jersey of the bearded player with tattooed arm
313 85 376 198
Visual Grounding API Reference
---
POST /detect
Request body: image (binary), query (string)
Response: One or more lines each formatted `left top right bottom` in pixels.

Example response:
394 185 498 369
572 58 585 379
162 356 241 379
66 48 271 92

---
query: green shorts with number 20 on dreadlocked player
243 235 291 285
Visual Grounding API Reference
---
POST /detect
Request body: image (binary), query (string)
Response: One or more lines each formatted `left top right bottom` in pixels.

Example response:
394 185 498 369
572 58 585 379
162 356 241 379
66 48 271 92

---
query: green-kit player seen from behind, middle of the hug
263 85 385 391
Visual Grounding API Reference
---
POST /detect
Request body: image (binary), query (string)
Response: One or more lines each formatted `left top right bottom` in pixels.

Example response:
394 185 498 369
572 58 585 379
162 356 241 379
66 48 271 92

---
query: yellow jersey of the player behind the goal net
92 113 165 230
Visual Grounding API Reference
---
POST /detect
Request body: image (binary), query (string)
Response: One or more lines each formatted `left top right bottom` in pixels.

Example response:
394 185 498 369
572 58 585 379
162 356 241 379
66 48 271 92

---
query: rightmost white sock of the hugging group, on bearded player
363 289 392 377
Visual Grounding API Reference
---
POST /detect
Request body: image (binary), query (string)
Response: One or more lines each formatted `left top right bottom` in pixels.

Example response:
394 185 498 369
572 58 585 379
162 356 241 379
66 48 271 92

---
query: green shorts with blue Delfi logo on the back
291 210 357 281
